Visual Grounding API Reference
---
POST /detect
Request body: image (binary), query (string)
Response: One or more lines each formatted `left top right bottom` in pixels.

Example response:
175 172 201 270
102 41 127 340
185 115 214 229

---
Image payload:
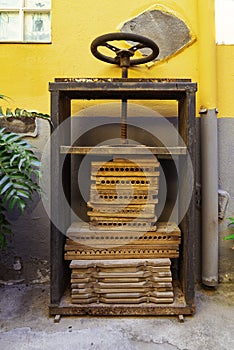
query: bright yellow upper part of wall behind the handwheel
0 0 234 116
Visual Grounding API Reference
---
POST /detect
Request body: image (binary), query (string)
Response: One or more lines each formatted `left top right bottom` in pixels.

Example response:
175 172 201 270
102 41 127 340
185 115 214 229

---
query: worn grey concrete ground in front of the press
0 284 234 350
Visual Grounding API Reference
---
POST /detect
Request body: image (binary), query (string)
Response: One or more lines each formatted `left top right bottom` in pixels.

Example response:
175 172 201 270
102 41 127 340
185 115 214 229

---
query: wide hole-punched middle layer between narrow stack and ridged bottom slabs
65 222 181 260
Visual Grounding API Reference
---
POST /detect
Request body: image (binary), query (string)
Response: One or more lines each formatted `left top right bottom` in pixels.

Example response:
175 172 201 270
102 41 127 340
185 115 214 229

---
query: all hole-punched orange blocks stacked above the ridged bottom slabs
65 158 180 260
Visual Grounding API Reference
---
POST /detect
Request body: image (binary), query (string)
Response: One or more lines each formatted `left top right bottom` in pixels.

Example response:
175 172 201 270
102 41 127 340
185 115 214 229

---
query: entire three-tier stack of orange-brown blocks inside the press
65 159 180 304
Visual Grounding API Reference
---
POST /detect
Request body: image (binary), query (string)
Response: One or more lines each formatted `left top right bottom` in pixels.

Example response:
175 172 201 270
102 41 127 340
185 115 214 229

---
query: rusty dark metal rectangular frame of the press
49 78 197 315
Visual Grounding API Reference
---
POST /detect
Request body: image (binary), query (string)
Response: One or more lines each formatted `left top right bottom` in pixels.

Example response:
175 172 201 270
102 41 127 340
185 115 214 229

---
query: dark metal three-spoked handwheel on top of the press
91 33 159 67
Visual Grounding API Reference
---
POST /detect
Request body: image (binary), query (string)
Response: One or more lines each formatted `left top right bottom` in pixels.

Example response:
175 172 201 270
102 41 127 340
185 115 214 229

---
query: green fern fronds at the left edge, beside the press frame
0 126 40 249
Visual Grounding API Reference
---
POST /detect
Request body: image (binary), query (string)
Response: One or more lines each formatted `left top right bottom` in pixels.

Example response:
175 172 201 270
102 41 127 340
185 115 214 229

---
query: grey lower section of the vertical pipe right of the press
201 109 219 287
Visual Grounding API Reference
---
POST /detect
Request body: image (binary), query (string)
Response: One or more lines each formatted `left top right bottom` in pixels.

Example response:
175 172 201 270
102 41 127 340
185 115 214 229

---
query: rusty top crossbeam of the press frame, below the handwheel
50 78 197 100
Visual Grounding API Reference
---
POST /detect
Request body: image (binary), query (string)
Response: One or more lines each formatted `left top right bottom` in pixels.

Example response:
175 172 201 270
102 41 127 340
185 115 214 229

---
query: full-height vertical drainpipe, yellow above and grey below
197 0 218 287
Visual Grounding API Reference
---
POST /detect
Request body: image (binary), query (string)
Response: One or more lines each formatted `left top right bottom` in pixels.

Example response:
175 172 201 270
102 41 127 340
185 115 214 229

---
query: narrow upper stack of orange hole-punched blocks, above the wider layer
88 158 159 232
